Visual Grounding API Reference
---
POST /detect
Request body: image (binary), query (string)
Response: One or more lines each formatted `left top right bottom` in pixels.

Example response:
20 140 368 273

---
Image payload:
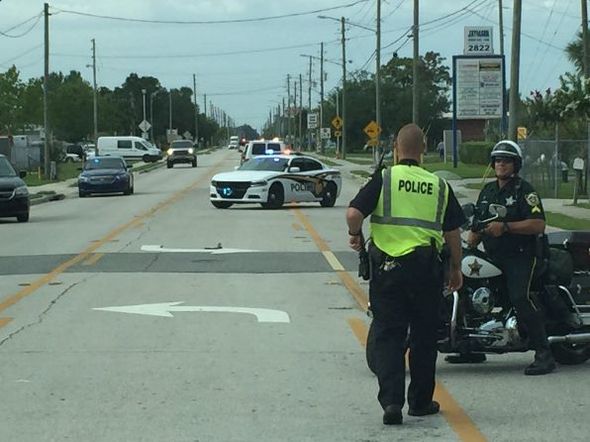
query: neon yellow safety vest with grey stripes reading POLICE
371 164 449 257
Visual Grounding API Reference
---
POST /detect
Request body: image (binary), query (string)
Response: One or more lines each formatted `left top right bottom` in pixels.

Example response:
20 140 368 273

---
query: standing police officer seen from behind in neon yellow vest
346 124 465 425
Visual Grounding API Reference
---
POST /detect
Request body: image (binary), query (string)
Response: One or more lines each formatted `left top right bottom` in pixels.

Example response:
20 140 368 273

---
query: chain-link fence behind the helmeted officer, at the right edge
519 139 590 199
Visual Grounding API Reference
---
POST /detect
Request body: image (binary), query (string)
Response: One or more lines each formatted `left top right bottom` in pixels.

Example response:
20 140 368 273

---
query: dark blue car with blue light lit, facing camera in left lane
78 156 134 198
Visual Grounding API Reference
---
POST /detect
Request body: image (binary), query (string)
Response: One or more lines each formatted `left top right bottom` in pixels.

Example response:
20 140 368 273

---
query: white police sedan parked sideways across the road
209 155 342 209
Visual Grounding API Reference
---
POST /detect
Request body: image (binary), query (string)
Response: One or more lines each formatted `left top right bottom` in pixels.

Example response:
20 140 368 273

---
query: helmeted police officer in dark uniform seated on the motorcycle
467 140 555 375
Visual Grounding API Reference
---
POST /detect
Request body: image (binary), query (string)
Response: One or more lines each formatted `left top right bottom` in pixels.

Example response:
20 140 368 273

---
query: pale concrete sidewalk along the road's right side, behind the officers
316 154 590 230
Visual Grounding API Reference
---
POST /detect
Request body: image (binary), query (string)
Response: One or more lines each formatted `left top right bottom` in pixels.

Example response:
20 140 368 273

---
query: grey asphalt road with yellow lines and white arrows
0 150 590 442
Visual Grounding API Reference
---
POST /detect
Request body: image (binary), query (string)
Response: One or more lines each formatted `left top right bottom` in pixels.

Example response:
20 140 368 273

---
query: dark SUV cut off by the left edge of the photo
0 154 31 223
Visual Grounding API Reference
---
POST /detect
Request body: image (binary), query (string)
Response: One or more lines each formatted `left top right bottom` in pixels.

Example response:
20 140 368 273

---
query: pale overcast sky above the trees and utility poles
0 0 581 130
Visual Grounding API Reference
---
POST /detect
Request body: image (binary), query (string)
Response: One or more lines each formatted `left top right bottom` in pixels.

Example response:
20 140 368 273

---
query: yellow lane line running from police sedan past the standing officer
292 208 487 442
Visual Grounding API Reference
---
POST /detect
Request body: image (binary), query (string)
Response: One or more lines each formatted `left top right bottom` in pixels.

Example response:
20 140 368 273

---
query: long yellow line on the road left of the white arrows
0 157 232 322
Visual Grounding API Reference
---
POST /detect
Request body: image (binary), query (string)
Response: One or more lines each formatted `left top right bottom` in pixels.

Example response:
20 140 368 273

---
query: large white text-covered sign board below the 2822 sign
453 55 505 120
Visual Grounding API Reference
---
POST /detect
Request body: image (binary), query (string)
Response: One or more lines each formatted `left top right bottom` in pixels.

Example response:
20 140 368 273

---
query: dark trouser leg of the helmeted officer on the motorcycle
494 253 549 350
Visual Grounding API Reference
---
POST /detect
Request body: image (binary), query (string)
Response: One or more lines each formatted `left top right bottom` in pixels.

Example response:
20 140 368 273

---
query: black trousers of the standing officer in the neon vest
369 248 443 408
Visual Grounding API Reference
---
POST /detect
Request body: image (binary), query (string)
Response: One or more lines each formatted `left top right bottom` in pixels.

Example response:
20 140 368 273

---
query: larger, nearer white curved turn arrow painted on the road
93 301 291 322
